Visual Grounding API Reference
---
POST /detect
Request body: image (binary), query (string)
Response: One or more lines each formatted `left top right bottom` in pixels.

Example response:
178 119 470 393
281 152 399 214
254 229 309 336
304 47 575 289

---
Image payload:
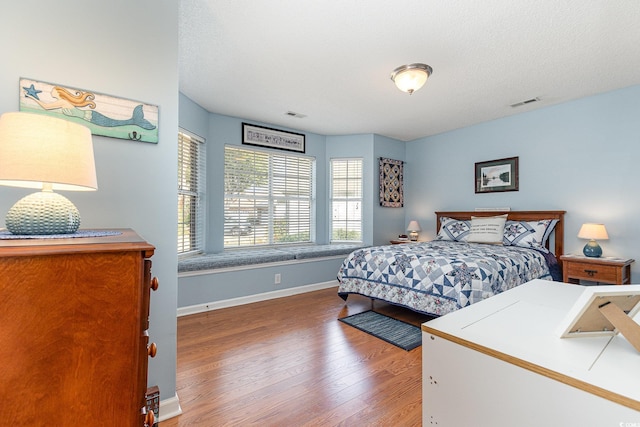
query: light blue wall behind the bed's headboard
405 86 640 276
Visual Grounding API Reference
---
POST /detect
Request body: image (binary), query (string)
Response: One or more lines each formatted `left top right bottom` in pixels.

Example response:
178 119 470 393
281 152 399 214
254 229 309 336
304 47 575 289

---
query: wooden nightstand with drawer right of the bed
560 255 634 285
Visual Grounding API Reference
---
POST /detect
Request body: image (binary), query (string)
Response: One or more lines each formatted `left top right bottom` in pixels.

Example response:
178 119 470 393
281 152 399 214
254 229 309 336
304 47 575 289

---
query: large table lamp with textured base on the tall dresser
0 112 98 235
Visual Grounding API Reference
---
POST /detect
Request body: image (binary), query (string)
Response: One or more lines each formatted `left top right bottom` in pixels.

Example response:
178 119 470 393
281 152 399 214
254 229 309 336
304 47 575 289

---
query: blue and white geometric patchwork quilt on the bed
338 241 552 316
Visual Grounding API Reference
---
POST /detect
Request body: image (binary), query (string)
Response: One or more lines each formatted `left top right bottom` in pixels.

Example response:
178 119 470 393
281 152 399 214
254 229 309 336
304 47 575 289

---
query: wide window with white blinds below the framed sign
224 146 315 248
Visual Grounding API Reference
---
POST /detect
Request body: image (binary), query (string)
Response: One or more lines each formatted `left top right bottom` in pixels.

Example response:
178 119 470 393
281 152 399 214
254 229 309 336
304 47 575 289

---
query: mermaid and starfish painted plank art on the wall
20 78 158 143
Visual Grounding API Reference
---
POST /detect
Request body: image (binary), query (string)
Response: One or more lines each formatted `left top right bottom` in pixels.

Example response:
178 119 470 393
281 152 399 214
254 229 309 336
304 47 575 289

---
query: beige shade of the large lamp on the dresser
0 112 98 191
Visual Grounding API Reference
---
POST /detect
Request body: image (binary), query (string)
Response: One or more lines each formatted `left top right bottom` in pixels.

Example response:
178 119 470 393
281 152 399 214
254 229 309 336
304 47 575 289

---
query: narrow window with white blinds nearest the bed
331 159 362 243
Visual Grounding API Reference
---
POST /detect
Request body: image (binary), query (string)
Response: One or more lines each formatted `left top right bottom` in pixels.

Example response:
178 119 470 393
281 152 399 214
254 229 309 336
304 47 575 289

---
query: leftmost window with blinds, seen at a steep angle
178 131 206 254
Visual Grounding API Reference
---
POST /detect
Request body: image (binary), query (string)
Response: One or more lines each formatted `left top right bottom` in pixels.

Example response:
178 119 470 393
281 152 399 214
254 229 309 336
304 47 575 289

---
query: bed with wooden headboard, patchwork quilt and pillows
338 211 565 316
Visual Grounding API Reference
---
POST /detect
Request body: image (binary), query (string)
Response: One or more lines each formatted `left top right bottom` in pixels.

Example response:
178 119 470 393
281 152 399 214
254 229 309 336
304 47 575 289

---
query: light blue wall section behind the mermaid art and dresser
0 0 178 399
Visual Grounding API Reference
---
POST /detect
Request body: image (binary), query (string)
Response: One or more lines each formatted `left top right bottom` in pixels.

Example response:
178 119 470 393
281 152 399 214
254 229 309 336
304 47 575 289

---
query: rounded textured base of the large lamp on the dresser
5 191 80 235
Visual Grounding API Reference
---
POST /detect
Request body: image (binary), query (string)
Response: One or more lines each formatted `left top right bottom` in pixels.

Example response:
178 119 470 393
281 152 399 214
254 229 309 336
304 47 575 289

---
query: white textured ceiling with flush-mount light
179 0 640 141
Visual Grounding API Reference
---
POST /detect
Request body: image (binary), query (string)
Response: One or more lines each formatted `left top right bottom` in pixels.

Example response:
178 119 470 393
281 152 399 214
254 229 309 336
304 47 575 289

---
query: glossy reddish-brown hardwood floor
159 288 436 427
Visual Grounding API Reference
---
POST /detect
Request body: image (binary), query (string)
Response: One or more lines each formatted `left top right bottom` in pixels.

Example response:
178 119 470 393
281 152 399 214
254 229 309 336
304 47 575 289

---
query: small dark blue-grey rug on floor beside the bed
338 310 422 351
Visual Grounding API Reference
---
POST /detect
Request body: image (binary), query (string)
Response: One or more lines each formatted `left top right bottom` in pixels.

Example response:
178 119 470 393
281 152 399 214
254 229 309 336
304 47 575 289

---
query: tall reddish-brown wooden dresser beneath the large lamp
0 229 158 427
